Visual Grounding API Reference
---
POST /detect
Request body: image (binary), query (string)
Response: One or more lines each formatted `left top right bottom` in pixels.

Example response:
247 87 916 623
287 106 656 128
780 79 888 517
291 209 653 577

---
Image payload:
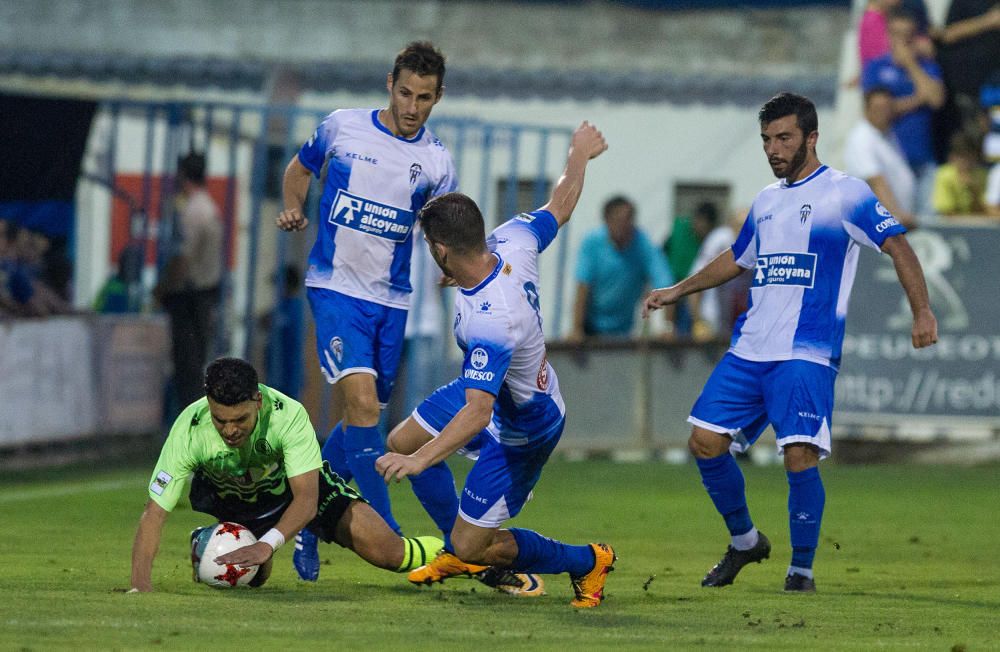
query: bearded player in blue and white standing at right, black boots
643 93 937 592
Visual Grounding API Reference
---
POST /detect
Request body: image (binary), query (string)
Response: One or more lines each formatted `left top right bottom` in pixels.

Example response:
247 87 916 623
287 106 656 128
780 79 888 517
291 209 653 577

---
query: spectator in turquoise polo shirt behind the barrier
569 196 673 341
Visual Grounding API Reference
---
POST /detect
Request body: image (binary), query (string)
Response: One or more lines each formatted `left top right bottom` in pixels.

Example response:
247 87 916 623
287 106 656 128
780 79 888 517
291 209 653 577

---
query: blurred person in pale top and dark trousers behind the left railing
153 152 223 408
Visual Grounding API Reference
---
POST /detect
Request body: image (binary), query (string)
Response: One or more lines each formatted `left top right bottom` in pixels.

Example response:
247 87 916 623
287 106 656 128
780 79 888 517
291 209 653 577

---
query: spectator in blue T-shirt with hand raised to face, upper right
861 11 945 214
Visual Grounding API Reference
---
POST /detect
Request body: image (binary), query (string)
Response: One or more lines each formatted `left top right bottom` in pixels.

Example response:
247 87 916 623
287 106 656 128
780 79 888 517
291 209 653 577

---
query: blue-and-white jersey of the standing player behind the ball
299 109 457 309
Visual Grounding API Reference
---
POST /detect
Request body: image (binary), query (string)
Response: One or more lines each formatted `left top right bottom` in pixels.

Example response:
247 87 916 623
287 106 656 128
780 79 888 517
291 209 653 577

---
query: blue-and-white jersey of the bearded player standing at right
730 165 906 368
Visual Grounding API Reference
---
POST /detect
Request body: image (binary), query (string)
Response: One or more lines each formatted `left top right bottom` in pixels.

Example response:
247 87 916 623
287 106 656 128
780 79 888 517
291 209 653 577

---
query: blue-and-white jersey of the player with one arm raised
455 211 566 445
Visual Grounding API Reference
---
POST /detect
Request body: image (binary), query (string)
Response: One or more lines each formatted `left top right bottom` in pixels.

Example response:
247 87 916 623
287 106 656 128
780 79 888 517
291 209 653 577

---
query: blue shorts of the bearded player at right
688 353 837 458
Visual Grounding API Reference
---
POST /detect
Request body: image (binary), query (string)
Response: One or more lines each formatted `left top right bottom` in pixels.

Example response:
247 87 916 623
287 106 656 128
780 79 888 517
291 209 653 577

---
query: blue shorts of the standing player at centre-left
306 287 406 407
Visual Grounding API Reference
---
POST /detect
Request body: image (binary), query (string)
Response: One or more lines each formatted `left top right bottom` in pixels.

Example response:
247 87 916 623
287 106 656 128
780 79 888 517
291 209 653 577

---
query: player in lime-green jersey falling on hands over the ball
132 358 442 592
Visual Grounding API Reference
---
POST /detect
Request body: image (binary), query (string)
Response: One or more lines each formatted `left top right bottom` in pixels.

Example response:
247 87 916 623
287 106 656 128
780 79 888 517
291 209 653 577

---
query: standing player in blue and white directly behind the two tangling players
277 42 456 580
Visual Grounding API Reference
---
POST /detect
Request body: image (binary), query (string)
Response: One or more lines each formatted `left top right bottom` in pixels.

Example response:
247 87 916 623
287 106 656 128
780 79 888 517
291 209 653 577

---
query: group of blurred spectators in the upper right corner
844 0 1000 227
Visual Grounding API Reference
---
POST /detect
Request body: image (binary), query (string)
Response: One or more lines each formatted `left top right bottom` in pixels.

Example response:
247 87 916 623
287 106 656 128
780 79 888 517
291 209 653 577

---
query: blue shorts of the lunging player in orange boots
413 380 566 528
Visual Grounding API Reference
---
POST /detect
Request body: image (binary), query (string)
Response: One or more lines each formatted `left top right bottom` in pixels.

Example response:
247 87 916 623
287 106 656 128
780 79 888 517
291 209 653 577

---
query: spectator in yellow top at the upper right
934 133 986 215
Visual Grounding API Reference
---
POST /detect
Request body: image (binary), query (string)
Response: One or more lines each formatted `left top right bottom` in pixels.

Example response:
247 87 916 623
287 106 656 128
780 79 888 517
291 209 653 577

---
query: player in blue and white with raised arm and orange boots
375 122 615 607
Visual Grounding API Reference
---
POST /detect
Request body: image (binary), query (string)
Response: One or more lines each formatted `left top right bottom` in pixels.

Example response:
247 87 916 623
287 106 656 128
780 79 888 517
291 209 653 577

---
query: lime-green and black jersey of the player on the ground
149 385 322 515
